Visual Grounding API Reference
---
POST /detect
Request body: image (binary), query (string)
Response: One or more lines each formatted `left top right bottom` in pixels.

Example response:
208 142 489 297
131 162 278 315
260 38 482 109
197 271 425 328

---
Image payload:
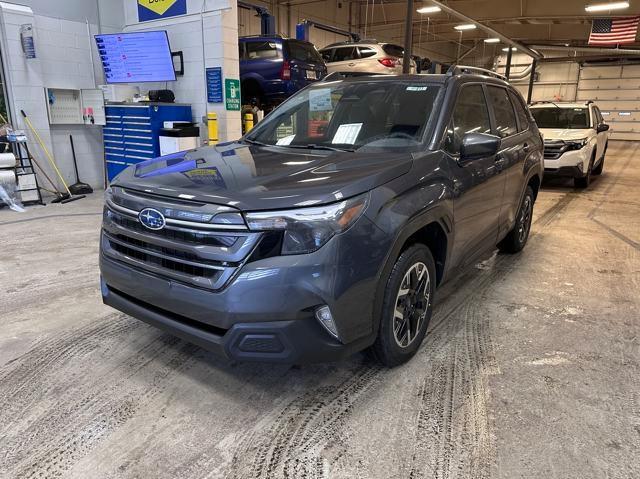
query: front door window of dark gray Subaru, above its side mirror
445 85 491 155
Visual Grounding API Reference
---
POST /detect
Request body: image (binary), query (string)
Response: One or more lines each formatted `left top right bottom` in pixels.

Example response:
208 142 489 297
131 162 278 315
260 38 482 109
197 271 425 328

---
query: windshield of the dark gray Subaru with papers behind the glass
245 81 441 150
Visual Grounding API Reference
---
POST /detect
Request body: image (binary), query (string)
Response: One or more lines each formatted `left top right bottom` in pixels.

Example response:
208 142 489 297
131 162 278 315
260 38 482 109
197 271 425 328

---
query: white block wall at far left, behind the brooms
0 2 103 193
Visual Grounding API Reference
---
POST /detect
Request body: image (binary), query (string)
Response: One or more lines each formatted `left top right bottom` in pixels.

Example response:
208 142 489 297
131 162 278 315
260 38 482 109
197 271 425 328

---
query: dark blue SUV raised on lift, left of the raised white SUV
238 35 327 110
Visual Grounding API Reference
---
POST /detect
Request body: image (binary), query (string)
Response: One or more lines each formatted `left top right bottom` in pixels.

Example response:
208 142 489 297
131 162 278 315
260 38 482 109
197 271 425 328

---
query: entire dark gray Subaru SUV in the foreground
100 67 543 366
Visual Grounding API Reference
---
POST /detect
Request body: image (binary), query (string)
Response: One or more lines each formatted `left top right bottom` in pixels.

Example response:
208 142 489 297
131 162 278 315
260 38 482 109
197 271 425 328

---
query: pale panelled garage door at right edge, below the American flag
577 65 640 140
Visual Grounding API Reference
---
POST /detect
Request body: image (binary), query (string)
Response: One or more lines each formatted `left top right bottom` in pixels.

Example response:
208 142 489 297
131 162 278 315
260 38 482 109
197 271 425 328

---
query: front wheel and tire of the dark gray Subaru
371 244 436 367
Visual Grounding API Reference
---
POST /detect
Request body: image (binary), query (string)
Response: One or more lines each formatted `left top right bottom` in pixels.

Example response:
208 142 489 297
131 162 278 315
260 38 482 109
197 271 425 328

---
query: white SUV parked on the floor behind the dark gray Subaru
530 101 609 188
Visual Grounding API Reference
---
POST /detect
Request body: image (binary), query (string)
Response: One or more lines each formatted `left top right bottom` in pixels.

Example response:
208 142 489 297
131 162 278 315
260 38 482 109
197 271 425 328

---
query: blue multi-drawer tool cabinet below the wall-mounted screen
103 103 192 181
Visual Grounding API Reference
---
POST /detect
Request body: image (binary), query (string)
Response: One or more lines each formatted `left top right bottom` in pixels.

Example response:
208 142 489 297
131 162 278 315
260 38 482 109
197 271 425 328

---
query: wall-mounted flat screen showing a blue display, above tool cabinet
96 31 176 83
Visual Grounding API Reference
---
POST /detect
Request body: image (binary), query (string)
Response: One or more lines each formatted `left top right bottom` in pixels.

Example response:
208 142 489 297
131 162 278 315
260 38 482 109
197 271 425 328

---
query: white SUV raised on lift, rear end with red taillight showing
320 41 416 74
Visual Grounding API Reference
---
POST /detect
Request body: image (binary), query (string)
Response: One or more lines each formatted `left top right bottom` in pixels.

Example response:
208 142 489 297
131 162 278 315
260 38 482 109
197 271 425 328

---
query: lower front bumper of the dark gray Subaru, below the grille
100 216 390 364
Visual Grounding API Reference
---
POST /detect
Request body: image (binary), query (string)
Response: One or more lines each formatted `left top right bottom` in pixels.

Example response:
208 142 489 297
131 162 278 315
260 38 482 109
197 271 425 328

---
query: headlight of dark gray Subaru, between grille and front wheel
245 195 368 255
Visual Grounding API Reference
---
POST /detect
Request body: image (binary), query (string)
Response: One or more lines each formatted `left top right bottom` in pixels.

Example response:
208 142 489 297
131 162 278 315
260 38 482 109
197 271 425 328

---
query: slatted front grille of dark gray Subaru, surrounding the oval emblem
102 192 263 291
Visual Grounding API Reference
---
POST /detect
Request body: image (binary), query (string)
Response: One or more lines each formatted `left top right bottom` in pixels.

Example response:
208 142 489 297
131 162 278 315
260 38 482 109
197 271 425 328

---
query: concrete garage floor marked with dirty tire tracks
0 143 640 479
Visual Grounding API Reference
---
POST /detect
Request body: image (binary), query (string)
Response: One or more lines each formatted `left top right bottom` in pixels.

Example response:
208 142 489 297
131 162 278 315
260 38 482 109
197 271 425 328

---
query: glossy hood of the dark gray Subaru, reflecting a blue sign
112 143 412 211
